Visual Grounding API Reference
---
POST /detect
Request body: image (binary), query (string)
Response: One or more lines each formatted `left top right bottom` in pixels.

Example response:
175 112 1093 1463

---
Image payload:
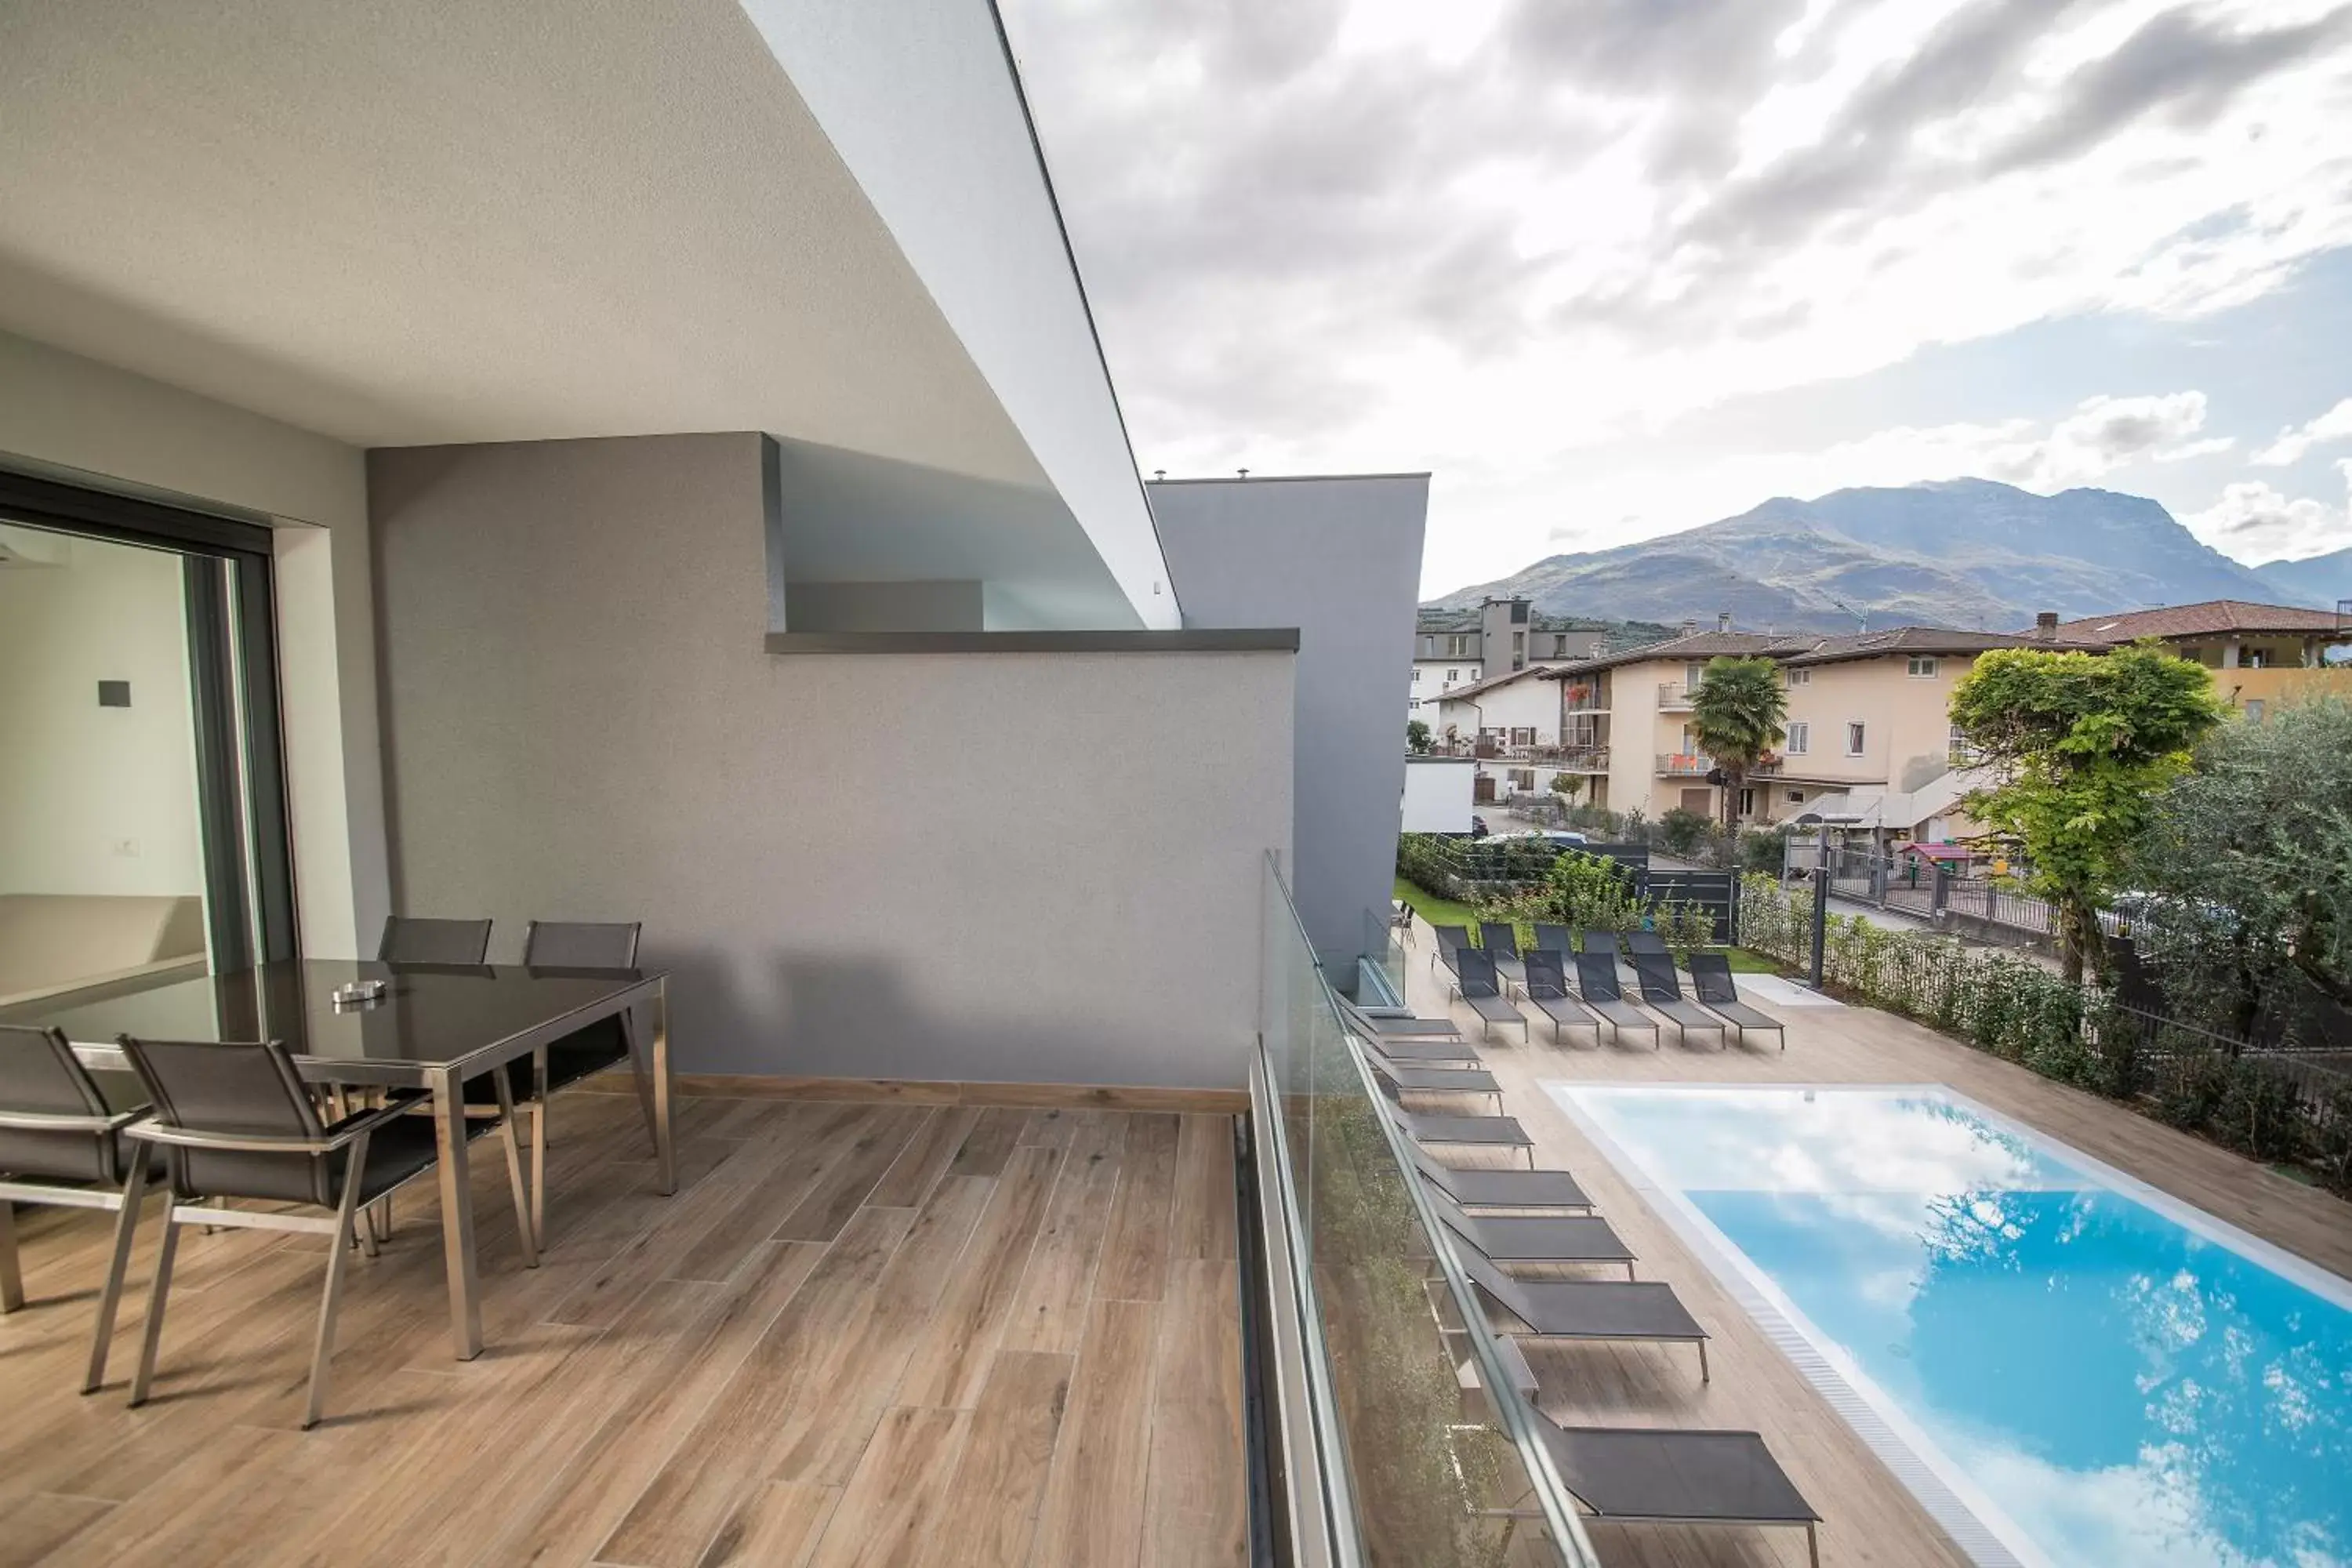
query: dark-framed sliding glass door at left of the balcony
0 473 294 1004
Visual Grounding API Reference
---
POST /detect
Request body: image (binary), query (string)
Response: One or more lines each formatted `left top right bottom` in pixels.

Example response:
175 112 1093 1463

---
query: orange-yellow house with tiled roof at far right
2032 600 2352 720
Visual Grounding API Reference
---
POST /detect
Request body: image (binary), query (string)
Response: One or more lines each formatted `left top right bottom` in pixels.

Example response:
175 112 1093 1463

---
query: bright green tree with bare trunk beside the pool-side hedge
1952 642 2225 982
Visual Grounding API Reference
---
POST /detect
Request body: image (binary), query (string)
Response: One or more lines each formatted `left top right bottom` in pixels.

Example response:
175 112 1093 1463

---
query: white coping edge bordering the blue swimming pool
1538 1079 2352 1568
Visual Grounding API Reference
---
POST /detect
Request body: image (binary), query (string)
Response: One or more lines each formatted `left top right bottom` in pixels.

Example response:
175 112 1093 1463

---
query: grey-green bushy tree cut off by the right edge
2129 696 2352 1034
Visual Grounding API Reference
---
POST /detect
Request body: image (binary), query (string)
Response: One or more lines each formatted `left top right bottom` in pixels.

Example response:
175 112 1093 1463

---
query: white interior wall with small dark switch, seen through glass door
0 536 205 895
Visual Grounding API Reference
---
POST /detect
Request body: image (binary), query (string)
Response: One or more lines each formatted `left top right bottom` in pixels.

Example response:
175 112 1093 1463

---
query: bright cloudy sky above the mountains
1004 0 2352 593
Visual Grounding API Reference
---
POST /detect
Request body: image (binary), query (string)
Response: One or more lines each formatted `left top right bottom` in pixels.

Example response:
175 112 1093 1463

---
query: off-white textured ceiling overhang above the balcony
0 0 1157 626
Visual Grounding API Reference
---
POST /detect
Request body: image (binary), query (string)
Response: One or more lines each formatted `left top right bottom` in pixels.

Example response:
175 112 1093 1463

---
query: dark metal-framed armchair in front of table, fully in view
106 1034 529 1429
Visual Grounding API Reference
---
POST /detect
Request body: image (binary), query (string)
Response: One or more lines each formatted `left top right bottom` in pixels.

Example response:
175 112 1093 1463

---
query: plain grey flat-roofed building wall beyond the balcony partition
1148 475 1430 964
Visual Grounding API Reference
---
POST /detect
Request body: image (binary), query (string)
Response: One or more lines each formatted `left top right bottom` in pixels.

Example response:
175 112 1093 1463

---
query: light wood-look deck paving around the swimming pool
1406 921 2352 1568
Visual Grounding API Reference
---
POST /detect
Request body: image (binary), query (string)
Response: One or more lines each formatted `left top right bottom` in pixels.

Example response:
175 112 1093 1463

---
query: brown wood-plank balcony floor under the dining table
0 1093 1247 1568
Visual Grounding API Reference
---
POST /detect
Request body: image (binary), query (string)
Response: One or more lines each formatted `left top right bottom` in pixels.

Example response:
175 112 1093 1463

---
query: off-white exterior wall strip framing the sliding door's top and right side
0 334 388 954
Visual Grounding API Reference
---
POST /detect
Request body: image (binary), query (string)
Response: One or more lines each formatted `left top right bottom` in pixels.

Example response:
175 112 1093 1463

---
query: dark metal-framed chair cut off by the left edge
0 1025 148 1394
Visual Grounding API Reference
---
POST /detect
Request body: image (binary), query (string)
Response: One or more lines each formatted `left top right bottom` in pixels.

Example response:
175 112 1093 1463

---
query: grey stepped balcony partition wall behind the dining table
369 435 1298 1086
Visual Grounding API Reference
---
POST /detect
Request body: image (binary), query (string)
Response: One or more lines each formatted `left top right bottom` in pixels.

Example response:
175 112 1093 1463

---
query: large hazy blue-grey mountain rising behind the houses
1430 480 2319 633
